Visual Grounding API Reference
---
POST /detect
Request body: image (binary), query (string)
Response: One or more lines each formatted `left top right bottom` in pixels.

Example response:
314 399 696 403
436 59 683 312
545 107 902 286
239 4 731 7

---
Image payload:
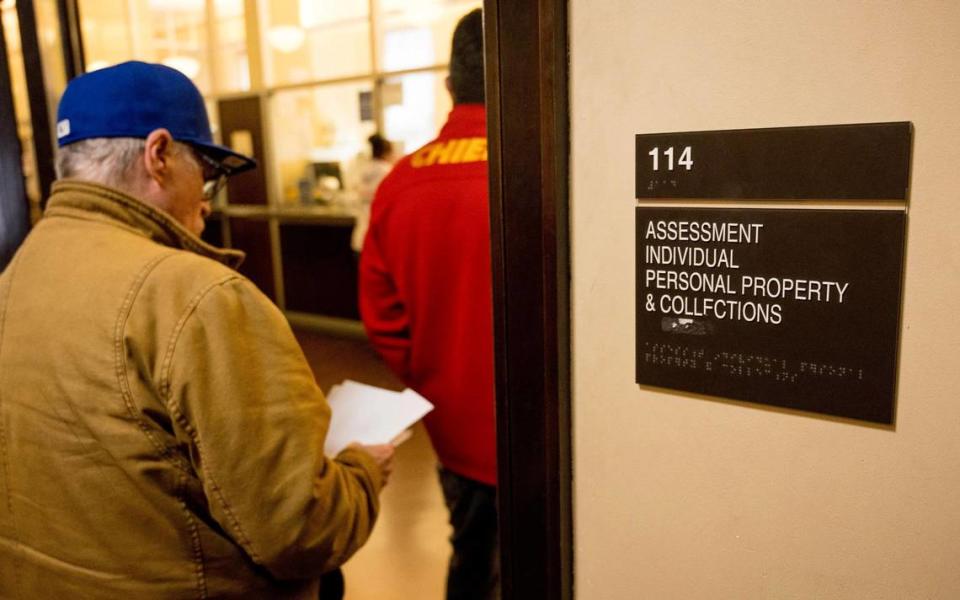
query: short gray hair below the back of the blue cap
56 137 146 189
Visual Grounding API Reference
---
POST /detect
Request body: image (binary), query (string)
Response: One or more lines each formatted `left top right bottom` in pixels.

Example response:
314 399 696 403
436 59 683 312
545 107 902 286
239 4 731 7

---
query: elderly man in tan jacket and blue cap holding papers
0 63 393 600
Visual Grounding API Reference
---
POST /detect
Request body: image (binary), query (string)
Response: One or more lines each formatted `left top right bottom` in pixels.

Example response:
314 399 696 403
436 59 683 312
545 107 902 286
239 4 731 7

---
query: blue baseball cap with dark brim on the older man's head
57 61 257 175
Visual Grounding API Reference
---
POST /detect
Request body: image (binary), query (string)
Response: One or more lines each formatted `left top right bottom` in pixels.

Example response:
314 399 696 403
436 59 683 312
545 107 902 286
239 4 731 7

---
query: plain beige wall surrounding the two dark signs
571 0 960 600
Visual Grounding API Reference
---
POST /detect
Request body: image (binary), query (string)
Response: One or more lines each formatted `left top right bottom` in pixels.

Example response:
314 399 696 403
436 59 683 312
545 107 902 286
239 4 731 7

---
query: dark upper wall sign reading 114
636 122 911 200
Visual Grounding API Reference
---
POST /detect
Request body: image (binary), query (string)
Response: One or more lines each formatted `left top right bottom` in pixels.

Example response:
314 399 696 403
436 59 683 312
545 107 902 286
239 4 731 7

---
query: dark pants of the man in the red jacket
439 467 500 600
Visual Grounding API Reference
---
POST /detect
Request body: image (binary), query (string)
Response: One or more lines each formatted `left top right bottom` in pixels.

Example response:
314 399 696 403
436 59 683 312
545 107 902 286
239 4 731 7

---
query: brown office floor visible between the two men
296 331 450 600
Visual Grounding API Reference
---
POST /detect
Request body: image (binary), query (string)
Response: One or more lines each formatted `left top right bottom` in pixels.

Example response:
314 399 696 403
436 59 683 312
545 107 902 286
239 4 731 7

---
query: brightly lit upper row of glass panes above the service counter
78 0 482 94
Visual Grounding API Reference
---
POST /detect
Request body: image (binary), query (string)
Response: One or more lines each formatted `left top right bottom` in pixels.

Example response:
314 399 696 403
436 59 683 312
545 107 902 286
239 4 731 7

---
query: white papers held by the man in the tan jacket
323 379 433 456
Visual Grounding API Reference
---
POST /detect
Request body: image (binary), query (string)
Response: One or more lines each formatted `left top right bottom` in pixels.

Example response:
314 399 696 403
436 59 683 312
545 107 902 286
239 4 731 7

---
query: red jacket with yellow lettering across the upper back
360 104 497 485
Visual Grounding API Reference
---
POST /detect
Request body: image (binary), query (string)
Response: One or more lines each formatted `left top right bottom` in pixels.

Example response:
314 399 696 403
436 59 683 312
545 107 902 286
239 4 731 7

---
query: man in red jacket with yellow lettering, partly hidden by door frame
360 9 499 599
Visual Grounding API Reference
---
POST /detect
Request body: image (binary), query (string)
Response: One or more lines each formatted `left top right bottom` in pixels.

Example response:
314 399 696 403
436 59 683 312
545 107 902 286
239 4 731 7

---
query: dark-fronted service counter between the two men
203 205 362 335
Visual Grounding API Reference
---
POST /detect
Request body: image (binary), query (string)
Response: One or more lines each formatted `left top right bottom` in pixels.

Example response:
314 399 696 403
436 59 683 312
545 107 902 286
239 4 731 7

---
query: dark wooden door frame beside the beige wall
484 0 573 600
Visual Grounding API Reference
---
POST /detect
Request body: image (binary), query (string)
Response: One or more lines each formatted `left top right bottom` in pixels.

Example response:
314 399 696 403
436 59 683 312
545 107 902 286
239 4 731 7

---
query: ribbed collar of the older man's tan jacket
44 180 245 269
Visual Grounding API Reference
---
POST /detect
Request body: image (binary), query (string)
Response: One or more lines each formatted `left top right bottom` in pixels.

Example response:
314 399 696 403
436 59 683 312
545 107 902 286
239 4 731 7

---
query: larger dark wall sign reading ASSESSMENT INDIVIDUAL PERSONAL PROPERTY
636 209 906 423
